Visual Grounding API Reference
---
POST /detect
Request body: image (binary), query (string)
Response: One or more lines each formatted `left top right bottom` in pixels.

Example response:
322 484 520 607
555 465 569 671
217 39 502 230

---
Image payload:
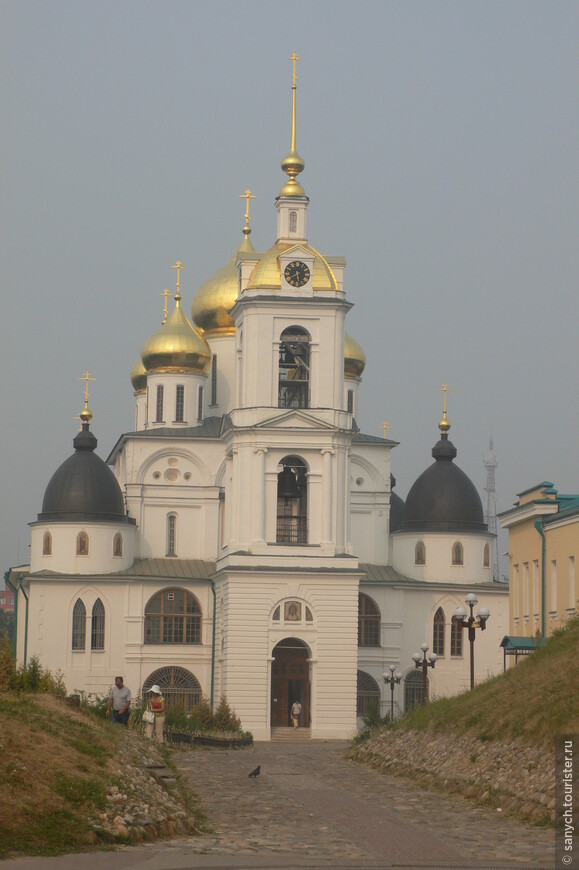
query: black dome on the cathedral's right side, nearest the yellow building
400 433 488 532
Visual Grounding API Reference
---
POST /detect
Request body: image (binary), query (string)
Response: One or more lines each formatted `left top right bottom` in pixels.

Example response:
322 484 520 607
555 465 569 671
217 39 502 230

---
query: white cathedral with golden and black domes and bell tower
10 62 508 740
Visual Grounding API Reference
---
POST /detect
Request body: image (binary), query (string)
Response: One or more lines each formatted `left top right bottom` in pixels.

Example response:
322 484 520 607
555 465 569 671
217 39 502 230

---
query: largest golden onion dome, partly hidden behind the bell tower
191 235 255 335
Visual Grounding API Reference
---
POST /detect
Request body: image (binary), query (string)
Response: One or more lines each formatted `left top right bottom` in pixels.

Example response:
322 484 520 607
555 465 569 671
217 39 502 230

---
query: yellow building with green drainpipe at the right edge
499 482 579 638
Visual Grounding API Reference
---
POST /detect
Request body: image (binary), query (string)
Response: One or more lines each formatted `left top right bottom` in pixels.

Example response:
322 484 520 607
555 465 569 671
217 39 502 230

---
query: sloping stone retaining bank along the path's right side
349 731 555 824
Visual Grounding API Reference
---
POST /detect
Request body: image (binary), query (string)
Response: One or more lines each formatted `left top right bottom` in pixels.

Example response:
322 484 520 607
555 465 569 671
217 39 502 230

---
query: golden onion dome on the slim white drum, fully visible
141 296 211 373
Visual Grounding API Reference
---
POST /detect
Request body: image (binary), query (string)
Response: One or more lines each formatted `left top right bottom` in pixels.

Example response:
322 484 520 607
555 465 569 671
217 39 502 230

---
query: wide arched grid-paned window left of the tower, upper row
145 589 201 644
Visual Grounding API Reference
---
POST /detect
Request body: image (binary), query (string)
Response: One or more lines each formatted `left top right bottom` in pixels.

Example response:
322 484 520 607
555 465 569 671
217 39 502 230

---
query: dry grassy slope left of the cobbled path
0 692 123 857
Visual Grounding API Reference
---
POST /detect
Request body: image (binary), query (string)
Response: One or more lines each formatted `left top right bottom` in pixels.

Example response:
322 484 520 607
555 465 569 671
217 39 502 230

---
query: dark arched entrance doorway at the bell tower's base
271 637 310 728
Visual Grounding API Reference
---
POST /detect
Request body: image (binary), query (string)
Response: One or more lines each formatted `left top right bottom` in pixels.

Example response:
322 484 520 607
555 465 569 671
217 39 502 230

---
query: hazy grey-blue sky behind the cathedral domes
0 0 579 571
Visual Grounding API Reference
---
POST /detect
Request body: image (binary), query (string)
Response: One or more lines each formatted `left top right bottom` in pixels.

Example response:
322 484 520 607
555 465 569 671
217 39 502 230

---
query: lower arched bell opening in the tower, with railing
276 456 308 544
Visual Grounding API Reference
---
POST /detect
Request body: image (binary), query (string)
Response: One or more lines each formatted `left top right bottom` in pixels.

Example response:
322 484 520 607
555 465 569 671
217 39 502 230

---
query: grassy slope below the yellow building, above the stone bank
395 617 579 745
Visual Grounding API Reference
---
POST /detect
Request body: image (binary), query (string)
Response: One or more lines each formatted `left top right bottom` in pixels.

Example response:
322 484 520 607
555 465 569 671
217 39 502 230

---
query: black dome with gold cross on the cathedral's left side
38 423 130 522
